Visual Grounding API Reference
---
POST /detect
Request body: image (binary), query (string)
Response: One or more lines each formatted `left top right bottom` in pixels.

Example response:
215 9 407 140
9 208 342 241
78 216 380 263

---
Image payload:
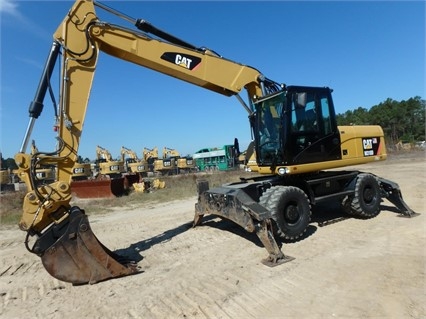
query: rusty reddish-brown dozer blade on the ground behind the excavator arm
71 177 125 198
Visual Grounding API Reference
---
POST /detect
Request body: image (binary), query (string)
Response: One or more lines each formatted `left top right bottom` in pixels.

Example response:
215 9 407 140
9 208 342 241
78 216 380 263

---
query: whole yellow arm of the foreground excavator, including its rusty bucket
15 0 278 283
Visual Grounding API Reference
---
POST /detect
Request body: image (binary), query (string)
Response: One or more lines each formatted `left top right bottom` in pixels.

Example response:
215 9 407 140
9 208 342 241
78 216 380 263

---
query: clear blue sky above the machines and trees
0 0 426 160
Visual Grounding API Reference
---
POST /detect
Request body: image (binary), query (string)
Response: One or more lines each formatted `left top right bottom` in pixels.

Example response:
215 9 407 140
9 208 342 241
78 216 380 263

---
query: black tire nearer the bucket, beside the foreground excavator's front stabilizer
259 186 311 240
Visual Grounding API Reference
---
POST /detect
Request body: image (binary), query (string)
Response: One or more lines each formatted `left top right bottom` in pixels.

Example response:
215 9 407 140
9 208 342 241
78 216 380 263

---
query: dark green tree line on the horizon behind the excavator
1 96 426 169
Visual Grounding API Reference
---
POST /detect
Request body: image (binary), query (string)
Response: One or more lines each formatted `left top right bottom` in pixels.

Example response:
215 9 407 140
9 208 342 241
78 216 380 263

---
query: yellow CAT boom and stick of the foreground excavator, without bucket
16 0 276 231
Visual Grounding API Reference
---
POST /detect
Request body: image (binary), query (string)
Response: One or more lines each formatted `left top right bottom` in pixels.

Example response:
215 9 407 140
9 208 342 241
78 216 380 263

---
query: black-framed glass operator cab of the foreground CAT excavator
253 86 341 167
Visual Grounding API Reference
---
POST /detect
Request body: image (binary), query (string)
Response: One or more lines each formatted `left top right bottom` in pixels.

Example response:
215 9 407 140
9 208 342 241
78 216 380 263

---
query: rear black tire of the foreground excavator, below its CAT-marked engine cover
346 173 382 218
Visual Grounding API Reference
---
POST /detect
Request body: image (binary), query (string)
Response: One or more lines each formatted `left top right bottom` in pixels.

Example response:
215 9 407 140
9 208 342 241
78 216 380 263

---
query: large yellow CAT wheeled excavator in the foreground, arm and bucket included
15 0 416 284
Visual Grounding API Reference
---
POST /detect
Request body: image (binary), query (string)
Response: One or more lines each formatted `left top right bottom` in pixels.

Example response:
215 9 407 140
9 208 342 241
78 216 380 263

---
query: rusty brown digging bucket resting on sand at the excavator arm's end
34 207 139 285
